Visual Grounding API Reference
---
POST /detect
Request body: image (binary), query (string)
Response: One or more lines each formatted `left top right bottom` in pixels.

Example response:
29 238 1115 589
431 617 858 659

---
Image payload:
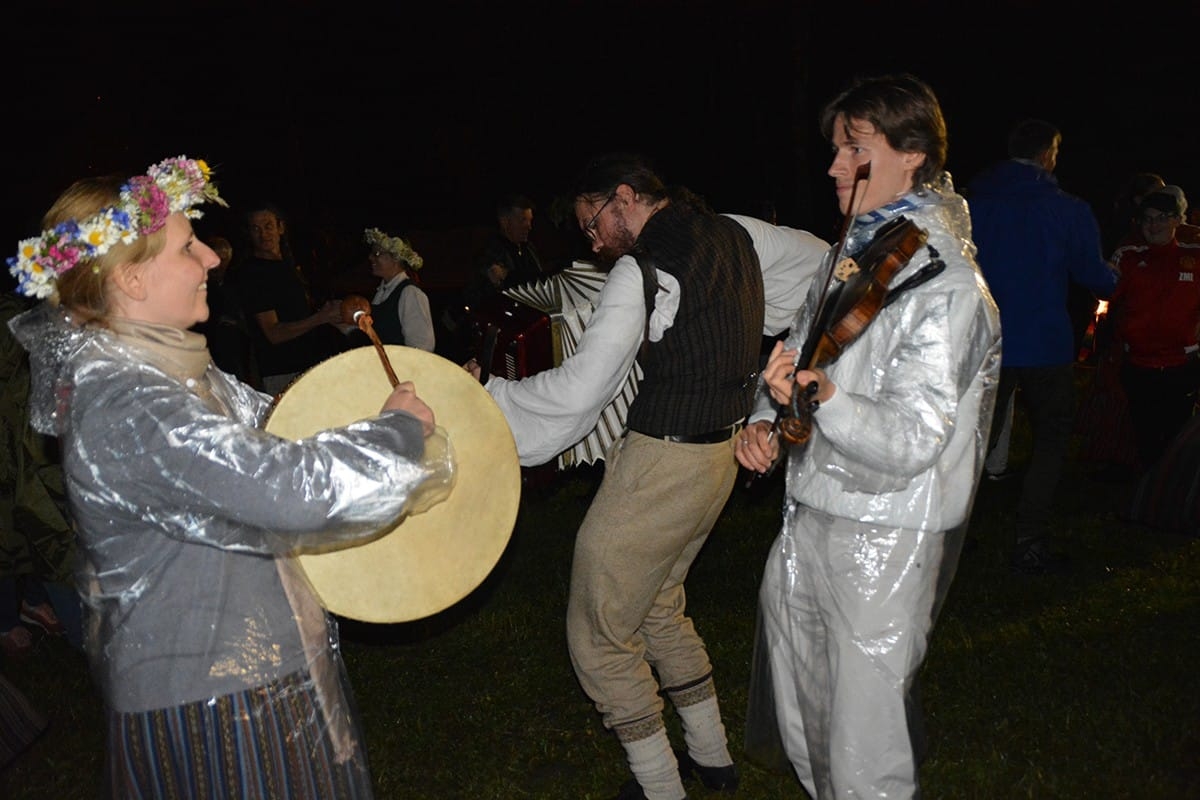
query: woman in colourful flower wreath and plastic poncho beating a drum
8 157 454 800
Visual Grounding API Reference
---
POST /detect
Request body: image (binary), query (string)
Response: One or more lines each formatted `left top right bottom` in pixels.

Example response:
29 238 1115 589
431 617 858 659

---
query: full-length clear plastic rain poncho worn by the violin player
746 175 1001 800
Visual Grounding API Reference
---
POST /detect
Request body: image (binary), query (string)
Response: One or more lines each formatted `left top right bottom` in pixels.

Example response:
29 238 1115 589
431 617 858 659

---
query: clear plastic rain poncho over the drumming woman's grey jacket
11 303 455 786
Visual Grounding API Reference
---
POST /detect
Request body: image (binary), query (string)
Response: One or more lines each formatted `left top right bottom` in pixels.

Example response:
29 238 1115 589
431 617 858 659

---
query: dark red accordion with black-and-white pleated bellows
472 261 642 469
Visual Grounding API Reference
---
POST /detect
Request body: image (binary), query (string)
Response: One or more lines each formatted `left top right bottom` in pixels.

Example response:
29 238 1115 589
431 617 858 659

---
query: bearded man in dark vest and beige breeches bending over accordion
468 155 763 800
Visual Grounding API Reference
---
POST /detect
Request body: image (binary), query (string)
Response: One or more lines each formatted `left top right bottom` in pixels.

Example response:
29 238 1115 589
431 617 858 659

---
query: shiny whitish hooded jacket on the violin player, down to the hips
750 174 1001 531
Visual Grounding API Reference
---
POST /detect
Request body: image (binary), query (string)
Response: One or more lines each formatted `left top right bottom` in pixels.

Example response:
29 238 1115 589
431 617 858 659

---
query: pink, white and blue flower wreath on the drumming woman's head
8 156 226 297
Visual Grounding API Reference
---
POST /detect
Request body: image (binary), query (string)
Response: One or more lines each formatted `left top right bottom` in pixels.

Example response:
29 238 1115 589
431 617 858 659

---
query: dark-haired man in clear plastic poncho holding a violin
736 76 1001 800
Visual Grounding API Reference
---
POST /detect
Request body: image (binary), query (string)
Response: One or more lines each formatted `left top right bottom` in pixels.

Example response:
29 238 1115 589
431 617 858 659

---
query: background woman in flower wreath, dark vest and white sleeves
354 228 437 353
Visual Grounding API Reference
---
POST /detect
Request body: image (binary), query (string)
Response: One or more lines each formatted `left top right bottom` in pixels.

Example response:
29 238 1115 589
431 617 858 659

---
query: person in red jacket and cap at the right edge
1109 186 1200 469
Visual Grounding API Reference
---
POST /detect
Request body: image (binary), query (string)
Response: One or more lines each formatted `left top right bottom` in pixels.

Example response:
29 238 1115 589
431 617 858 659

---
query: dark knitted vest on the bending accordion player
625 203 763 435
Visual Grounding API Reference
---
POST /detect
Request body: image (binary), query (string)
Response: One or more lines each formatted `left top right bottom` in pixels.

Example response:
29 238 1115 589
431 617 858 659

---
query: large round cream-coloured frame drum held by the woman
266 344 521 622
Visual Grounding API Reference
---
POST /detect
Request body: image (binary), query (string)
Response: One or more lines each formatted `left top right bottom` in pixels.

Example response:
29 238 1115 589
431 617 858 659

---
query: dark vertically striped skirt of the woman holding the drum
106 672 372 800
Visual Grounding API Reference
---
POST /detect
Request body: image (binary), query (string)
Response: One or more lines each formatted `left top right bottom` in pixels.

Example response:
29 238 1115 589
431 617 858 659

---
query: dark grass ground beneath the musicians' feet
0 402 1200 800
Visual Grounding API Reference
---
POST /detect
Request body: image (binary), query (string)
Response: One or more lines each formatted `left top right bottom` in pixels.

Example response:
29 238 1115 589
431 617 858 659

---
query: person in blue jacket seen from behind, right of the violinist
967 119 1117 575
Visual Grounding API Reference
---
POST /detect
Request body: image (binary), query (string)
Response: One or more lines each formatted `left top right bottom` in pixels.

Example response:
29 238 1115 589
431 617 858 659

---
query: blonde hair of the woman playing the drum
42 175 167 323
